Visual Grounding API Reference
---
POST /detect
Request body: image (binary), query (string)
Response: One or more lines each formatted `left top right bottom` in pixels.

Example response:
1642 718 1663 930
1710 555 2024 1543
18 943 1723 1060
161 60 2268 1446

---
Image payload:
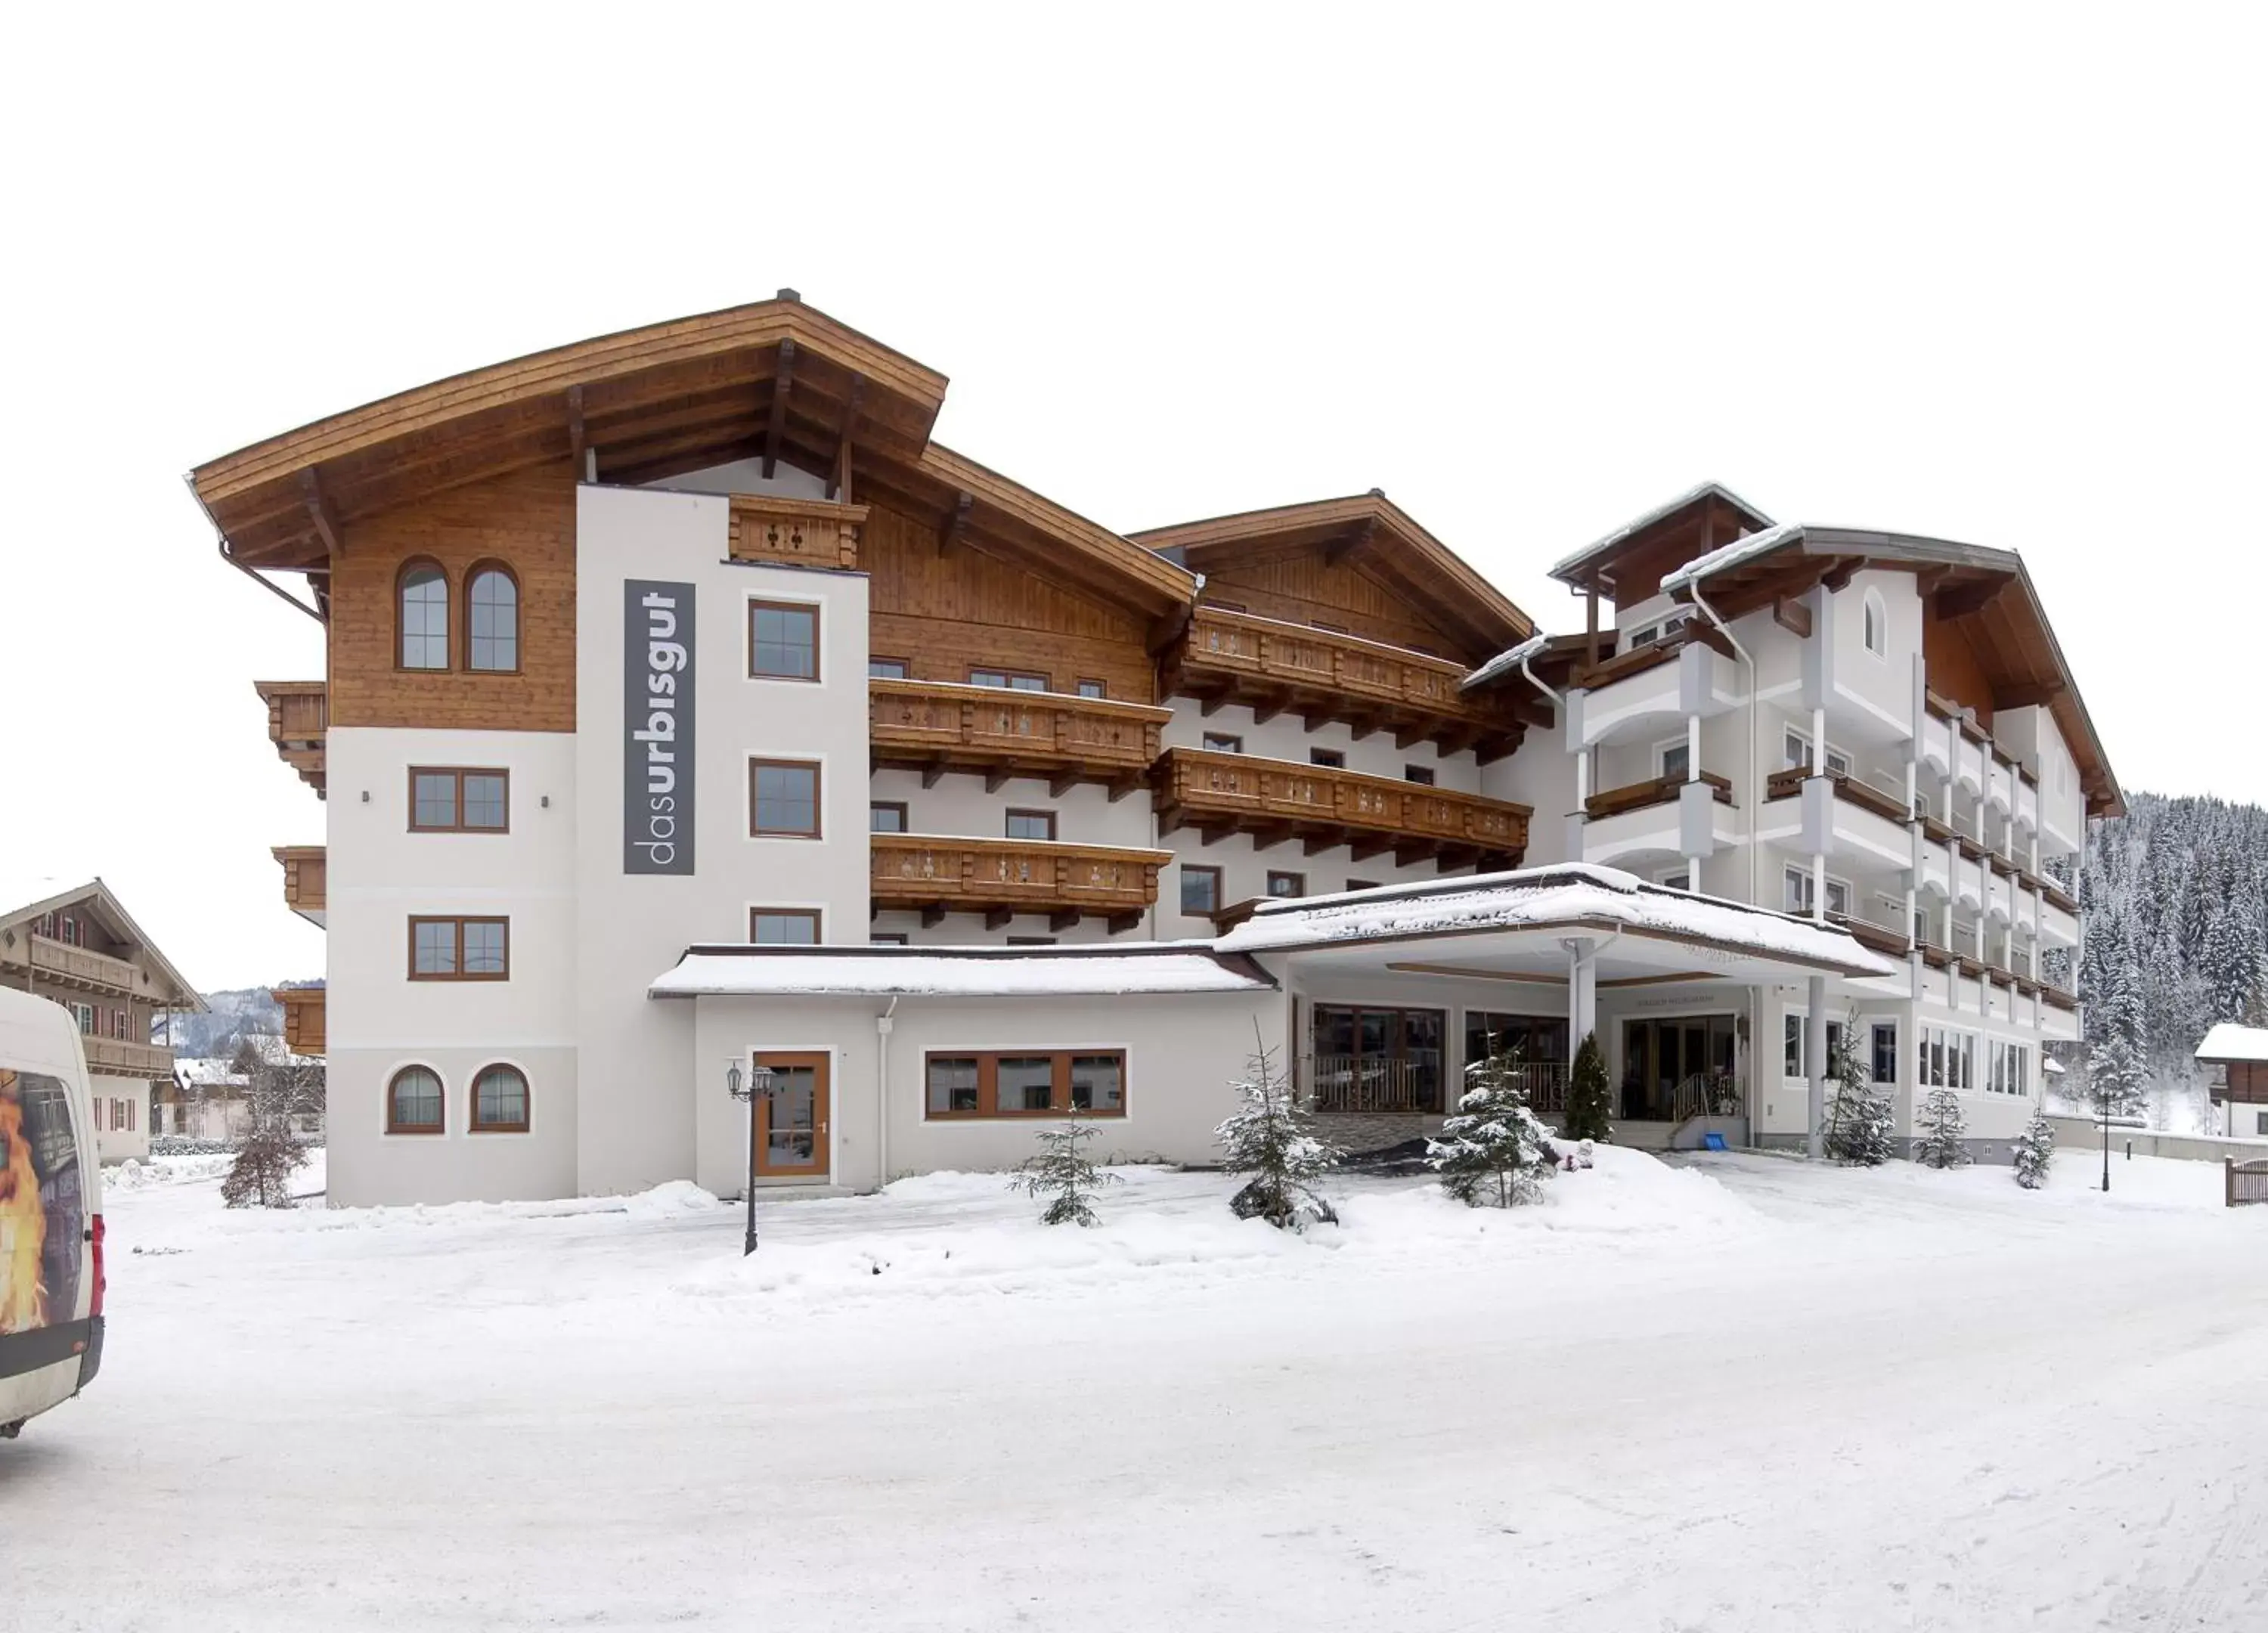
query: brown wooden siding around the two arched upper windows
331 463 574 733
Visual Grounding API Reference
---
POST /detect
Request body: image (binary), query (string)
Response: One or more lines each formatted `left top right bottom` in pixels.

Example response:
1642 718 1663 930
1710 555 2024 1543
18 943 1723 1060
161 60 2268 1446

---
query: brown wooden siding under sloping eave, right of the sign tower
860 504 1157 703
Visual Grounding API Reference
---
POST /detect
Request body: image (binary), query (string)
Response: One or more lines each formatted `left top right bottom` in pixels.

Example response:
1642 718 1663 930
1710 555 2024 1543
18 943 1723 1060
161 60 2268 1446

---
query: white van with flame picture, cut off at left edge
0 975 102 1440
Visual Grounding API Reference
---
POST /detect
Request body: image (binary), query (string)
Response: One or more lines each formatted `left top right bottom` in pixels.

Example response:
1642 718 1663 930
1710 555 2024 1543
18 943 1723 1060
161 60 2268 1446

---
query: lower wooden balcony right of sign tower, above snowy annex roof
866 835 1173 932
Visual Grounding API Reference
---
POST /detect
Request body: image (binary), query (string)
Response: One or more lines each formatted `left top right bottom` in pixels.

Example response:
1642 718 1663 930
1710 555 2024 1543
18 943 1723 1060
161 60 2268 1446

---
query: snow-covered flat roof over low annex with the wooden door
646 941 1275 998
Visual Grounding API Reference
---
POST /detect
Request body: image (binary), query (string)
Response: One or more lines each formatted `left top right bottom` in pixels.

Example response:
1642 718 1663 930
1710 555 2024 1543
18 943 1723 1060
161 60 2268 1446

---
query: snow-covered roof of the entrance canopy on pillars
1218 862 1896 975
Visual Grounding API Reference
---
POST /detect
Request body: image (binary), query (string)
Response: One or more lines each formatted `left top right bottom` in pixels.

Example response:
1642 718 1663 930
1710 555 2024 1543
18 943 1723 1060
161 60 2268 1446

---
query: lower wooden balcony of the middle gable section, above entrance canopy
1150 748 1533 871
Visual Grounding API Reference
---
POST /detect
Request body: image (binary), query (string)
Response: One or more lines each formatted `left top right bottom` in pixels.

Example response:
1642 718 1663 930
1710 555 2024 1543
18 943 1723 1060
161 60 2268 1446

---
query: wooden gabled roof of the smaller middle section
1127 488 1535 651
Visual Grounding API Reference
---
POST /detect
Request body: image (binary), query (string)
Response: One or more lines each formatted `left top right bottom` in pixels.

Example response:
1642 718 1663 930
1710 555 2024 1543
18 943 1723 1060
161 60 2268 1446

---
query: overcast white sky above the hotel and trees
0 5 2268 989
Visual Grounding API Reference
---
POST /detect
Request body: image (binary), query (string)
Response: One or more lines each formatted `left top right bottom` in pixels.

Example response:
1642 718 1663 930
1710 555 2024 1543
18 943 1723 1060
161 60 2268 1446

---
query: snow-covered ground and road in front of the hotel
0 1150 2268 1633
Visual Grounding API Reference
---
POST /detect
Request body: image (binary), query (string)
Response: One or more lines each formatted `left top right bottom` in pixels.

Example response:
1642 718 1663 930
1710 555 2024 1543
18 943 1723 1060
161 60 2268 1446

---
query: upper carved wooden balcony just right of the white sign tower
866 680 1173 801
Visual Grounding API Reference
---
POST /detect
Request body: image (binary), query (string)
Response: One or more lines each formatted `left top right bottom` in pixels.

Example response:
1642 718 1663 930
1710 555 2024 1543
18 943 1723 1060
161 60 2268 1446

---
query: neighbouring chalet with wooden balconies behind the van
0 878 204 1161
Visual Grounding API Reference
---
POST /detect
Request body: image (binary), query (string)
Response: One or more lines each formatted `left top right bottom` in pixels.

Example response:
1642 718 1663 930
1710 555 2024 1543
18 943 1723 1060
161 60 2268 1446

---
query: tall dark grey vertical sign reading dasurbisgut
621 578 694 873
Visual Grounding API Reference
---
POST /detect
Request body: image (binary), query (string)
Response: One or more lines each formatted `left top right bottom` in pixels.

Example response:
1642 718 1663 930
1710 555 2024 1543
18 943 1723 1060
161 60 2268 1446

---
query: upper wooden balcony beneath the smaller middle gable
1161 606 1538 764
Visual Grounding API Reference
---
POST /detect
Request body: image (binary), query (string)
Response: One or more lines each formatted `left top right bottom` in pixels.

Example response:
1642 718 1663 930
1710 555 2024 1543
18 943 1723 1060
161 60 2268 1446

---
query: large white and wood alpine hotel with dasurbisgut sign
191 290 2118 1202
